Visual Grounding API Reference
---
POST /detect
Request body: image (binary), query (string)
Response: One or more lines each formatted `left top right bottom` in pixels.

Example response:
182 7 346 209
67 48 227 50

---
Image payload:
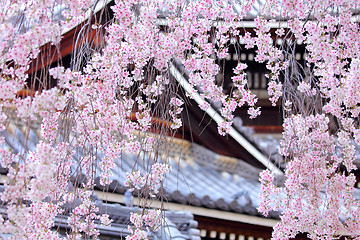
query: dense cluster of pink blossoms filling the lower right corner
259 115 360 239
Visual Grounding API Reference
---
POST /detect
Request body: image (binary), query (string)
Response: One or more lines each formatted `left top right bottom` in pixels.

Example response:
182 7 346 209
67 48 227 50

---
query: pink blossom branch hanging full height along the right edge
259 1 360 239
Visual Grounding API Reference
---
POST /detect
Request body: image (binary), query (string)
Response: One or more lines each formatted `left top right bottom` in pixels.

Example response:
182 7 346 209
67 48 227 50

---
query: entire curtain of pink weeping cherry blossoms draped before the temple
0 0 360 239
